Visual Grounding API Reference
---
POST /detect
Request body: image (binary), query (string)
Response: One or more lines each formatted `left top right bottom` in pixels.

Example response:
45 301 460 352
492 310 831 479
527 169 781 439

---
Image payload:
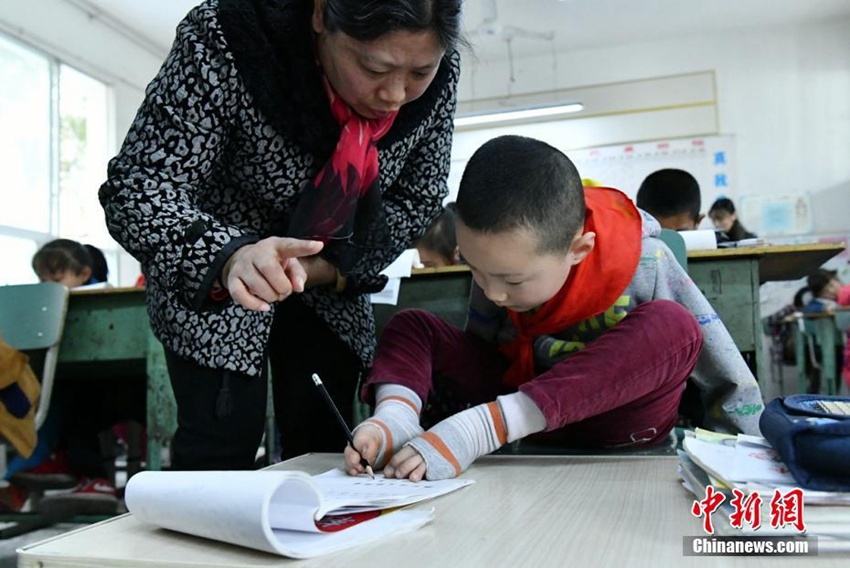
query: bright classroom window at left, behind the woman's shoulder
0 34 112 285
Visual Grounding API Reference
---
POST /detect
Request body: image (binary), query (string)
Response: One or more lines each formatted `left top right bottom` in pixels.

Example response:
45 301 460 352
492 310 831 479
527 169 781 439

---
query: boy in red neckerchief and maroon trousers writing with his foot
345 136 763 481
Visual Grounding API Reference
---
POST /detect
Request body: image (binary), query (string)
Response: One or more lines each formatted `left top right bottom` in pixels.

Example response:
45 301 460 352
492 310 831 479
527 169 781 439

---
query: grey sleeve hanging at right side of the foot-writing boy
644 241 764 435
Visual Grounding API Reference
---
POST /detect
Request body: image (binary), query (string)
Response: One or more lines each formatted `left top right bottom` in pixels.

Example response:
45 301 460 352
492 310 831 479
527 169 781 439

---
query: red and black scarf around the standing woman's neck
291 78 398 242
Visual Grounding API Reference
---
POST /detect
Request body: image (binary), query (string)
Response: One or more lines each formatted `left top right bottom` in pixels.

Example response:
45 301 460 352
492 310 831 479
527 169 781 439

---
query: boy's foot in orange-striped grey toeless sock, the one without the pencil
384 392 546 481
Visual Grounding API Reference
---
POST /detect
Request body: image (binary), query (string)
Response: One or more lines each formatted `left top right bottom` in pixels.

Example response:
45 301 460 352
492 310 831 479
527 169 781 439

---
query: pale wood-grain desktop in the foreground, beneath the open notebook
18 454 847 568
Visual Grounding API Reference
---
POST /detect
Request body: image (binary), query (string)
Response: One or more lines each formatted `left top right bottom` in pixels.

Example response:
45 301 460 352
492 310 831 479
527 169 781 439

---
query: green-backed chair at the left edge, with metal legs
0 282 68 539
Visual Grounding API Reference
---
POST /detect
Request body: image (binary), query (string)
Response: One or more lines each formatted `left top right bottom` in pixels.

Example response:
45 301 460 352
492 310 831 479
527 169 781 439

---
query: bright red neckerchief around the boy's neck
500 187 642 387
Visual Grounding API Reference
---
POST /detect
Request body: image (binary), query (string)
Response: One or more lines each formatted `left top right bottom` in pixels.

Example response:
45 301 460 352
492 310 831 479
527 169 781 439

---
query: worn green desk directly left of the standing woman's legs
57 288 177 470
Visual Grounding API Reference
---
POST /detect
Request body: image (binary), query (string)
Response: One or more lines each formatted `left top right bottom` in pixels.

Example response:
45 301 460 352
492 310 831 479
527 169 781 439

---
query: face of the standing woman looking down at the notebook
313 2 444 118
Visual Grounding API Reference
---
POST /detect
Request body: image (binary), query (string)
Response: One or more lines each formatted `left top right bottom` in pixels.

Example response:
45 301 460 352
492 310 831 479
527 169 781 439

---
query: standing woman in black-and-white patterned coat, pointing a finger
99 0 462 470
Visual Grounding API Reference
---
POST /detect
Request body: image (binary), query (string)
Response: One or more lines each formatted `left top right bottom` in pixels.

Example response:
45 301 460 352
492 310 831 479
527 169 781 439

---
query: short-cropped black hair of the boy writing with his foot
456 136 585 253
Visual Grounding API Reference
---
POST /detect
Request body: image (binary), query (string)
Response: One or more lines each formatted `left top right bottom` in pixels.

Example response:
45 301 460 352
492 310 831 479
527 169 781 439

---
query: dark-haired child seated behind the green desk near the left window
7 239 146 514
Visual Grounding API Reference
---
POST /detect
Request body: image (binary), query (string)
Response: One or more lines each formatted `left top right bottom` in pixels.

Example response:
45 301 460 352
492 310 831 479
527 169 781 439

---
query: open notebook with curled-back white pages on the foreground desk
125 470 474 558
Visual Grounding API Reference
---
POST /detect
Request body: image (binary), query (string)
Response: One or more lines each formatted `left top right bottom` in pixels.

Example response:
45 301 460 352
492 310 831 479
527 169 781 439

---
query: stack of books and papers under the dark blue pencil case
678 428 850 551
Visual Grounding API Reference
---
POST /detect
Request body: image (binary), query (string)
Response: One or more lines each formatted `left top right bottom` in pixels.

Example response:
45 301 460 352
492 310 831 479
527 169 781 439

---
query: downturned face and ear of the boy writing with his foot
455 220 596 312
